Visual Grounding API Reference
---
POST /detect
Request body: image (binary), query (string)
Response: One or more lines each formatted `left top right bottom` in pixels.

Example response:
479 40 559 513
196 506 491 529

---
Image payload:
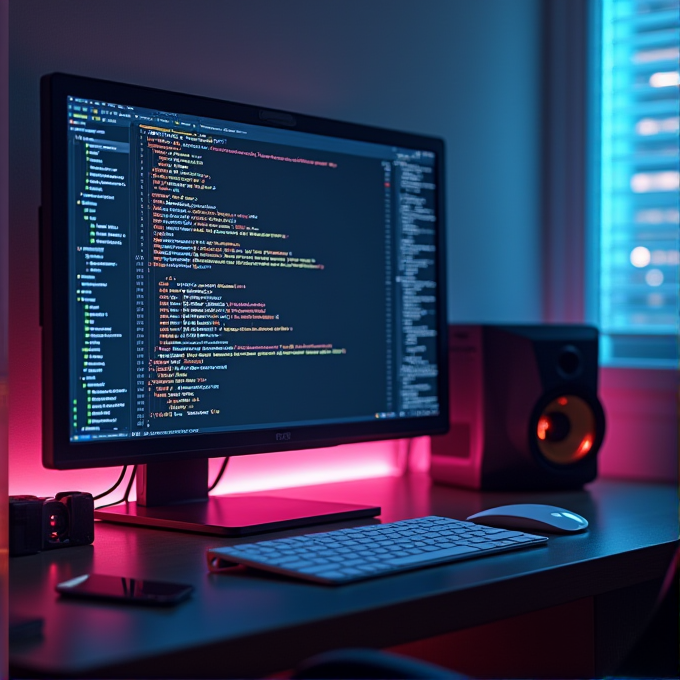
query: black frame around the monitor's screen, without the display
40 73 449 470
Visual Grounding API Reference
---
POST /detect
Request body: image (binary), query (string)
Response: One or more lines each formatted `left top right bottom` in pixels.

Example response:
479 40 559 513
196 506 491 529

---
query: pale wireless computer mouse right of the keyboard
468 503 588 534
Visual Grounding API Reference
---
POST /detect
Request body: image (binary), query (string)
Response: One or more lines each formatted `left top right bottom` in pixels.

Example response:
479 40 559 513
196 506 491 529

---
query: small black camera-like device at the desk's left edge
9 491 94 556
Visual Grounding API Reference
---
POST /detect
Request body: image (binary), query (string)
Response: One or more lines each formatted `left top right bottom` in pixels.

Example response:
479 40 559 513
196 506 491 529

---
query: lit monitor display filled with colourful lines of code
69 98 438 441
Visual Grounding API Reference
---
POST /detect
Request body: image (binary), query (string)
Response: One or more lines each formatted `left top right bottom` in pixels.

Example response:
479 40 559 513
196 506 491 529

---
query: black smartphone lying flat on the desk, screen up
55 574 194 606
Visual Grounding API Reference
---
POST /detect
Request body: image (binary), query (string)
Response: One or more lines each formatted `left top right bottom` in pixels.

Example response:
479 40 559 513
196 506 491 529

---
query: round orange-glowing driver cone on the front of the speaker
535 394 597 465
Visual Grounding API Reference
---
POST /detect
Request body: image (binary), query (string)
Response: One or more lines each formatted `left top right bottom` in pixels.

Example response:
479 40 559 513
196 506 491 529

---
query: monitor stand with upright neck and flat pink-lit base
94 458 380 536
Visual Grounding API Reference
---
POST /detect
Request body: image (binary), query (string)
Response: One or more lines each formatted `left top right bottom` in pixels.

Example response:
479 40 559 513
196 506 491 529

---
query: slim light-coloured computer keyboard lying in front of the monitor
207 516 548 585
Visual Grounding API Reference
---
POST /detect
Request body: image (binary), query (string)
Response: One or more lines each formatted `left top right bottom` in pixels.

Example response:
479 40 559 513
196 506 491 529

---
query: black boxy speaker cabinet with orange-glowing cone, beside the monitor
430 325 605 490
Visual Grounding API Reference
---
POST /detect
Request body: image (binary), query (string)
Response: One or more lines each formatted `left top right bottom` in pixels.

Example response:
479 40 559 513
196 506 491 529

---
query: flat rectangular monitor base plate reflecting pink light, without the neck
94 494 380 536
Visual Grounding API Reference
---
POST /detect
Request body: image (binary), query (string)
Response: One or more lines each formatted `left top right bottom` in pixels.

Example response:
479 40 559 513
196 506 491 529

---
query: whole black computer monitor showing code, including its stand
41 74 448 533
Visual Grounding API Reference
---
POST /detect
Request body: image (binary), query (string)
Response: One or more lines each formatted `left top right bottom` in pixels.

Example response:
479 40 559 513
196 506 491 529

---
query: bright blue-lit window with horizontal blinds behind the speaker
589 0 680 368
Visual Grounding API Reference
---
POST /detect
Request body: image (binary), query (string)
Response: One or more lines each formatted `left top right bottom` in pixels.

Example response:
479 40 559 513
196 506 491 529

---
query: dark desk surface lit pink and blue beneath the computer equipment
10 474 678 678
